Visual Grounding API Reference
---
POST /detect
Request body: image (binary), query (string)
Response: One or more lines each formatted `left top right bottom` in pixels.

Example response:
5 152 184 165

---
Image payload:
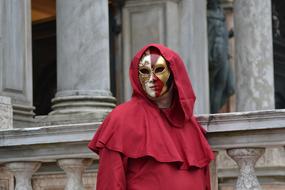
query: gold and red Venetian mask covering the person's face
139 50 171 99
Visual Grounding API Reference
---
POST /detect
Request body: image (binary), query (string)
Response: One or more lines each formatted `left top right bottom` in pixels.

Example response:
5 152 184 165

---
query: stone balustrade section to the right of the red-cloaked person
199 110 285 190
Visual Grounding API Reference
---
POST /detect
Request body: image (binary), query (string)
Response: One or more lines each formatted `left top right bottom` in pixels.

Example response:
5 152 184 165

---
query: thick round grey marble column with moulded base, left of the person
51 0 115 114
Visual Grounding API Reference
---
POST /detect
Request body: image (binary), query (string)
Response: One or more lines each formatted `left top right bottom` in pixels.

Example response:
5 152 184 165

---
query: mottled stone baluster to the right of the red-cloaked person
227 148 265 190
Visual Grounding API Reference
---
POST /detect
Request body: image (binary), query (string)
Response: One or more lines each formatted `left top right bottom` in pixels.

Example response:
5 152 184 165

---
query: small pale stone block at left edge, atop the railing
0 96 13 130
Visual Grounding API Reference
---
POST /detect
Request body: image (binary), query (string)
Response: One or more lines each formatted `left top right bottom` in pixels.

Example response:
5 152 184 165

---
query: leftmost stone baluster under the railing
5 162 41 190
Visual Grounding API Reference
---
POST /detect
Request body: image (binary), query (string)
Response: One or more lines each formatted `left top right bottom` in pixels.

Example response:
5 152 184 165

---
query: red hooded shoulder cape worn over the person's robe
88 44 214 169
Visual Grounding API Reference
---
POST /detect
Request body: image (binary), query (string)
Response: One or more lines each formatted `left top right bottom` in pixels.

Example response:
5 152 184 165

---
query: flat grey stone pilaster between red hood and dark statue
179 0 210 114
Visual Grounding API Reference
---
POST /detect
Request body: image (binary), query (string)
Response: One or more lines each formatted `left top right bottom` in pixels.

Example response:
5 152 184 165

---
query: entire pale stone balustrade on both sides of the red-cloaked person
0 110 285 190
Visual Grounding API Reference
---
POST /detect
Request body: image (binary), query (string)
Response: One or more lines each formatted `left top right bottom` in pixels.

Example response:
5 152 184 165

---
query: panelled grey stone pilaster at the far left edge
0 0 34 127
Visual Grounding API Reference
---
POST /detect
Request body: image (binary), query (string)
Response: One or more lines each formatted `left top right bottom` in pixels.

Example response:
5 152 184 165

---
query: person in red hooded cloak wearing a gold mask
88 44 214 190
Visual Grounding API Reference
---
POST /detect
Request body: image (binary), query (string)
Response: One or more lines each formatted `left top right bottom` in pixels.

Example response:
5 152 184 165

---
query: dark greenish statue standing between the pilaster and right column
207 0 234 113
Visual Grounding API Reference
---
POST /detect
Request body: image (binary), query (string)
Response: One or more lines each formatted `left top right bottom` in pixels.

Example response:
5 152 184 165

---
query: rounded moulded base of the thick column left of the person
50 95 116 115
